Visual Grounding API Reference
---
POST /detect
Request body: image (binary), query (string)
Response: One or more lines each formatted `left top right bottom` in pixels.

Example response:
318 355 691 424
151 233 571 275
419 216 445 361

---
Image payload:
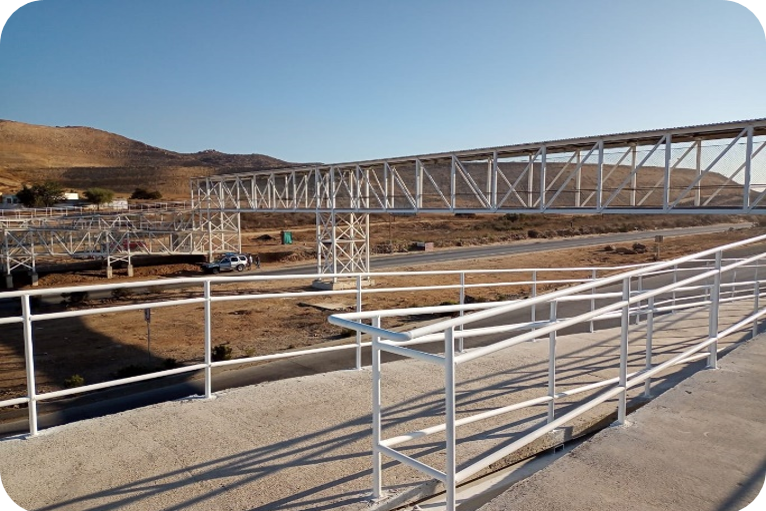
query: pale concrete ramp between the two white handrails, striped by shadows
0 306 762 511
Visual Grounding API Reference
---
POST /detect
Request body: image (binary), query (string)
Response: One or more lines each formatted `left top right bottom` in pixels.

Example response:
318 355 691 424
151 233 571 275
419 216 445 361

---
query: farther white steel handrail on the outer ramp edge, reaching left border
0 265 664 435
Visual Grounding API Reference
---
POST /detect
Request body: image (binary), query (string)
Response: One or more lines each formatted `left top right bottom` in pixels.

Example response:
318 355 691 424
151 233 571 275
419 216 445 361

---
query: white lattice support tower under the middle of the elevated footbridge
314 212 370 289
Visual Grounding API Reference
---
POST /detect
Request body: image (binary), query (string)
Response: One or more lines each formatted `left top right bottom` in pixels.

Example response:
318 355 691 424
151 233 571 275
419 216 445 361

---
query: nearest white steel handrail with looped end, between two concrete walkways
329 236 766 510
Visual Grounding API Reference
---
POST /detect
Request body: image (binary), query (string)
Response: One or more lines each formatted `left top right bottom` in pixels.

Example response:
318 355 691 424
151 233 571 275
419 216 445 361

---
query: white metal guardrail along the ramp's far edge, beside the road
0 265 664 435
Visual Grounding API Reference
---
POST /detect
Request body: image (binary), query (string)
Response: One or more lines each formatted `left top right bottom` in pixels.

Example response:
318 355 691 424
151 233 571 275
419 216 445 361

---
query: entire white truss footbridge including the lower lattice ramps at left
0 119 766 288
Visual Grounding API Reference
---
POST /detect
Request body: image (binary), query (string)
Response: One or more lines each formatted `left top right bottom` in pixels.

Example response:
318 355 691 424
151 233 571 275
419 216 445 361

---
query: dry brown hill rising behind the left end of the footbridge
0 120 292 198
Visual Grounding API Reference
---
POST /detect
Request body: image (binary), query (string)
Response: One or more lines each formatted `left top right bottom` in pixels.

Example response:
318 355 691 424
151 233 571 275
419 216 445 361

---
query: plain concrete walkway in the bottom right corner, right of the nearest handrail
481 336 766 511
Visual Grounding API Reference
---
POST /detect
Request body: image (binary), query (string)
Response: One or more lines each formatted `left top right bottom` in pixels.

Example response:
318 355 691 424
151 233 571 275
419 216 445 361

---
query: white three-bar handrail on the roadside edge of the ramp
0 247 764 444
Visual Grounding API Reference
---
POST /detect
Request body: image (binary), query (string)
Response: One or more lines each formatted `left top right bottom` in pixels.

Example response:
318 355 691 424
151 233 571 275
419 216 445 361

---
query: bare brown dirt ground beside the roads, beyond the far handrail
0 221 764 408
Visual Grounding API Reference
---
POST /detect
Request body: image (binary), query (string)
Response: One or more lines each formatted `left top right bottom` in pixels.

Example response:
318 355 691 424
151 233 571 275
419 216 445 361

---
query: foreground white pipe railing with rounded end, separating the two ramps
329 236 766 509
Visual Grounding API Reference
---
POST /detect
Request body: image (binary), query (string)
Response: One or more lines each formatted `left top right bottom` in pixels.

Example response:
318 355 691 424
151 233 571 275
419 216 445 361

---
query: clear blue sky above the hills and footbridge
0 0 766 163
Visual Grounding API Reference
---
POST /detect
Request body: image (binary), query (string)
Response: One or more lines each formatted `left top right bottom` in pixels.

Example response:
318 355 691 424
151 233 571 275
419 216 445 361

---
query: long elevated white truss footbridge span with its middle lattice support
192 119 766 280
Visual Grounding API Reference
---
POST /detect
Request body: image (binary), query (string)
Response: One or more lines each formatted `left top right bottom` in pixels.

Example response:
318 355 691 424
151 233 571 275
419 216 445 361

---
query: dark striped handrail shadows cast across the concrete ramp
21 308 764 511
